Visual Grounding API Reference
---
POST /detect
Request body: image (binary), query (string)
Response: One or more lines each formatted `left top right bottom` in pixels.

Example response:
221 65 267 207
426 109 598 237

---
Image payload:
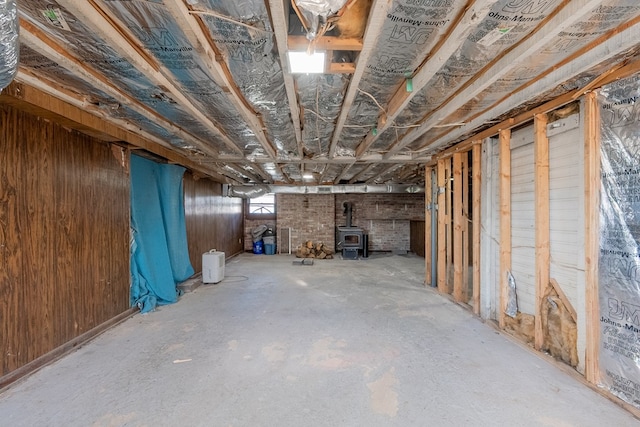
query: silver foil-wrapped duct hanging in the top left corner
0 0 20 90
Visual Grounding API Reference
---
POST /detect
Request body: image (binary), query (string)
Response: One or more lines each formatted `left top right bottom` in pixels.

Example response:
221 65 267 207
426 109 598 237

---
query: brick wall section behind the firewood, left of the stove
276 194 336 253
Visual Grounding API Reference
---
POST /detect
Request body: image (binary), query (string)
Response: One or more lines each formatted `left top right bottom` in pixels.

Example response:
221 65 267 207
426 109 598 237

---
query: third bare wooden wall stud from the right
498 129 511 328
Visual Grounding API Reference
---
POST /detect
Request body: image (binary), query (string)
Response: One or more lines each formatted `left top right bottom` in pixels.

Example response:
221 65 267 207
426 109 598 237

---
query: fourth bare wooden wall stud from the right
452 153 467 302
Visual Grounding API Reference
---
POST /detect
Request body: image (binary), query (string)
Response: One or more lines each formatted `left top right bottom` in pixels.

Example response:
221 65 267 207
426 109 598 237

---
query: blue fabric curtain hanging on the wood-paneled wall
130 155 194 313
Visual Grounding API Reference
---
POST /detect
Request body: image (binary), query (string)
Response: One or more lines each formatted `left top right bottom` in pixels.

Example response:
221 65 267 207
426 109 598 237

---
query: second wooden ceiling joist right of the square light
356 0 498 157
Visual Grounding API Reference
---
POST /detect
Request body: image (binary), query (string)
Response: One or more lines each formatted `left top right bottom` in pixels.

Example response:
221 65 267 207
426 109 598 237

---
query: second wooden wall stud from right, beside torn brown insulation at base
534 114 550 350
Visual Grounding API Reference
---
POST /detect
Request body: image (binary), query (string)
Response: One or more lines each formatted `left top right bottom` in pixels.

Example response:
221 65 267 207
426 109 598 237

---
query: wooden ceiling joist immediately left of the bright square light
269 0 304 159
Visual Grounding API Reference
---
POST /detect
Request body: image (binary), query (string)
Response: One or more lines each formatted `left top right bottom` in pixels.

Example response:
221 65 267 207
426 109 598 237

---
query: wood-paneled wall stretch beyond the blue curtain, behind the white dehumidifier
184 172 244 272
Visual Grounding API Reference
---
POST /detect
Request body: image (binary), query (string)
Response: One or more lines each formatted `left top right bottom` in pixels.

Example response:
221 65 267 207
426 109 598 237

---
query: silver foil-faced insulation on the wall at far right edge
598 76 640 408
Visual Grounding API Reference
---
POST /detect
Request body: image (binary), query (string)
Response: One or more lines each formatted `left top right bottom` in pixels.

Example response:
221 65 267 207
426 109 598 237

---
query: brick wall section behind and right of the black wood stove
335 193 425 251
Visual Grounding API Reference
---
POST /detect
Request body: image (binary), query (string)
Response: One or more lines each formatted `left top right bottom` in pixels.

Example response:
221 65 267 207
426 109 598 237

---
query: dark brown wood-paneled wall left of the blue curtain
0 105 129 383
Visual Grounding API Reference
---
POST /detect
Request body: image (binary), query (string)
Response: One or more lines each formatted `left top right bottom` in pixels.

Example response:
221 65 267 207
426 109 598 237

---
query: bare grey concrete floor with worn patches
0 254 638 427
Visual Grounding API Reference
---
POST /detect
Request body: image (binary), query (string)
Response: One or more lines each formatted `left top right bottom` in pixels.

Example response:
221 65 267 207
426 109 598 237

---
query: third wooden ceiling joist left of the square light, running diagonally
58 0 244 159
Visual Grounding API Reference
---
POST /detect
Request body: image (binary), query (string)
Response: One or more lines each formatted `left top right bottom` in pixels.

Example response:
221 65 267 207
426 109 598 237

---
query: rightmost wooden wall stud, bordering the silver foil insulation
584 92 600 385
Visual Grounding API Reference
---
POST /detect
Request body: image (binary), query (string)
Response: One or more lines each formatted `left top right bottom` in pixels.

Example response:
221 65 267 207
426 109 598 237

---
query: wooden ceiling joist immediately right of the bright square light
329 0 392 159
